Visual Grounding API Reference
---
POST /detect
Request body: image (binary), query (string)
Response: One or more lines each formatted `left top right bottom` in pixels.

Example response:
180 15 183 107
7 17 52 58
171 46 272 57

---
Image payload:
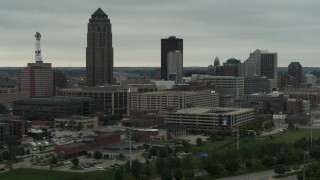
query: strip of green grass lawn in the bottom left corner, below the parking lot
0 168 114 180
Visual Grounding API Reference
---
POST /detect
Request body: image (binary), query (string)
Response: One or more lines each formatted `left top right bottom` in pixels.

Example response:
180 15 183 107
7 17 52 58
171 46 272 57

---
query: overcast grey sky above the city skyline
0 0 320 67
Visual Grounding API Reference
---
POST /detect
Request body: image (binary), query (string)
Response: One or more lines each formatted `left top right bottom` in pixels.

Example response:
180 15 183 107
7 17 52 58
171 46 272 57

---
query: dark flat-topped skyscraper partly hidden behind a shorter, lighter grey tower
161 36 183 80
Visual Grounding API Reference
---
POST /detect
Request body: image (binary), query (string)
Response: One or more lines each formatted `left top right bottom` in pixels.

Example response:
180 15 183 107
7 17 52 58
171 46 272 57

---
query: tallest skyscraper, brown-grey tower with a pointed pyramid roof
86 8 113 86
